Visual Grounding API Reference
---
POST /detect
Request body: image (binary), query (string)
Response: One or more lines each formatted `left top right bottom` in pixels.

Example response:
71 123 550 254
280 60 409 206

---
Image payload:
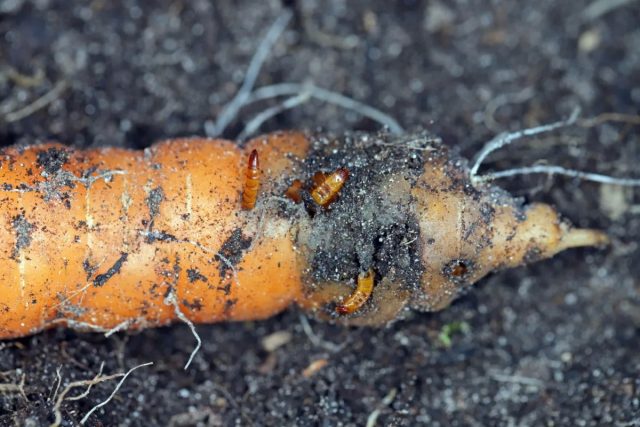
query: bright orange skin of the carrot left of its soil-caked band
0 134 310 338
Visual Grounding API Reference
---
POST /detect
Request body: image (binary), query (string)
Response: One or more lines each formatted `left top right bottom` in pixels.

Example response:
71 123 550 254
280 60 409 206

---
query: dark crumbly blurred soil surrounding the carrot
0 0 640 426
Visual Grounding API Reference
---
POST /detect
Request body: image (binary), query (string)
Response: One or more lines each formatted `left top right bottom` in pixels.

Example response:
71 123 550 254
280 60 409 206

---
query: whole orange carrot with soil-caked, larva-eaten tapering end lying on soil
0 132 608 339
